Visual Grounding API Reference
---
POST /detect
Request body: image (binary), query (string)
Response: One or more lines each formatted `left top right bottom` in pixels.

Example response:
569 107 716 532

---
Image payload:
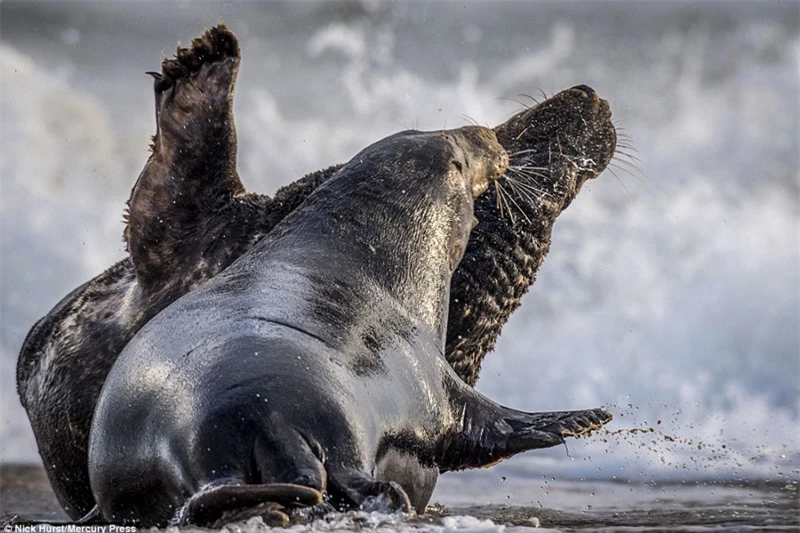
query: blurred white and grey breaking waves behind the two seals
0 1 800 490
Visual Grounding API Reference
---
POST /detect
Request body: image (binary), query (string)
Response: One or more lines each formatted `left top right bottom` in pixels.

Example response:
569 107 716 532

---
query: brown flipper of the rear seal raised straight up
125 24 244 291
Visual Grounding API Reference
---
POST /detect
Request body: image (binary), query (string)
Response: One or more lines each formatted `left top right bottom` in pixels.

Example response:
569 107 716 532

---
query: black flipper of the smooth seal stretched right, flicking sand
438 387 612 472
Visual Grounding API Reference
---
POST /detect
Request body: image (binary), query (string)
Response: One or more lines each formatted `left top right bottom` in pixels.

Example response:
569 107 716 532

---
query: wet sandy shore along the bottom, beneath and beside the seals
0 464 800 533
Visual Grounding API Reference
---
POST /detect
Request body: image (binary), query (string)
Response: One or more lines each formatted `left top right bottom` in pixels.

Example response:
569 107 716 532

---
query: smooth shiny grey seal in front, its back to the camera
89 127 611 527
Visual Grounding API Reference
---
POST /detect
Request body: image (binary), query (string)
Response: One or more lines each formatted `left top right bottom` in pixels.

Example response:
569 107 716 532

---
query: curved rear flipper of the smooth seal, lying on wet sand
177 483 322 529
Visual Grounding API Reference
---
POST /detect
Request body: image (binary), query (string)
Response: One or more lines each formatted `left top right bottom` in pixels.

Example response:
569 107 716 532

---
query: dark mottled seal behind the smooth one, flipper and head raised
17 26 616 519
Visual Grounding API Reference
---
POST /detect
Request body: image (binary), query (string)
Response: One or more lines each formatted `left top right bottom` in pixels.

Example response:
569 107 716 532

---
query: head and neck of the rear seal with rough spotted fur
446 86 616 386
